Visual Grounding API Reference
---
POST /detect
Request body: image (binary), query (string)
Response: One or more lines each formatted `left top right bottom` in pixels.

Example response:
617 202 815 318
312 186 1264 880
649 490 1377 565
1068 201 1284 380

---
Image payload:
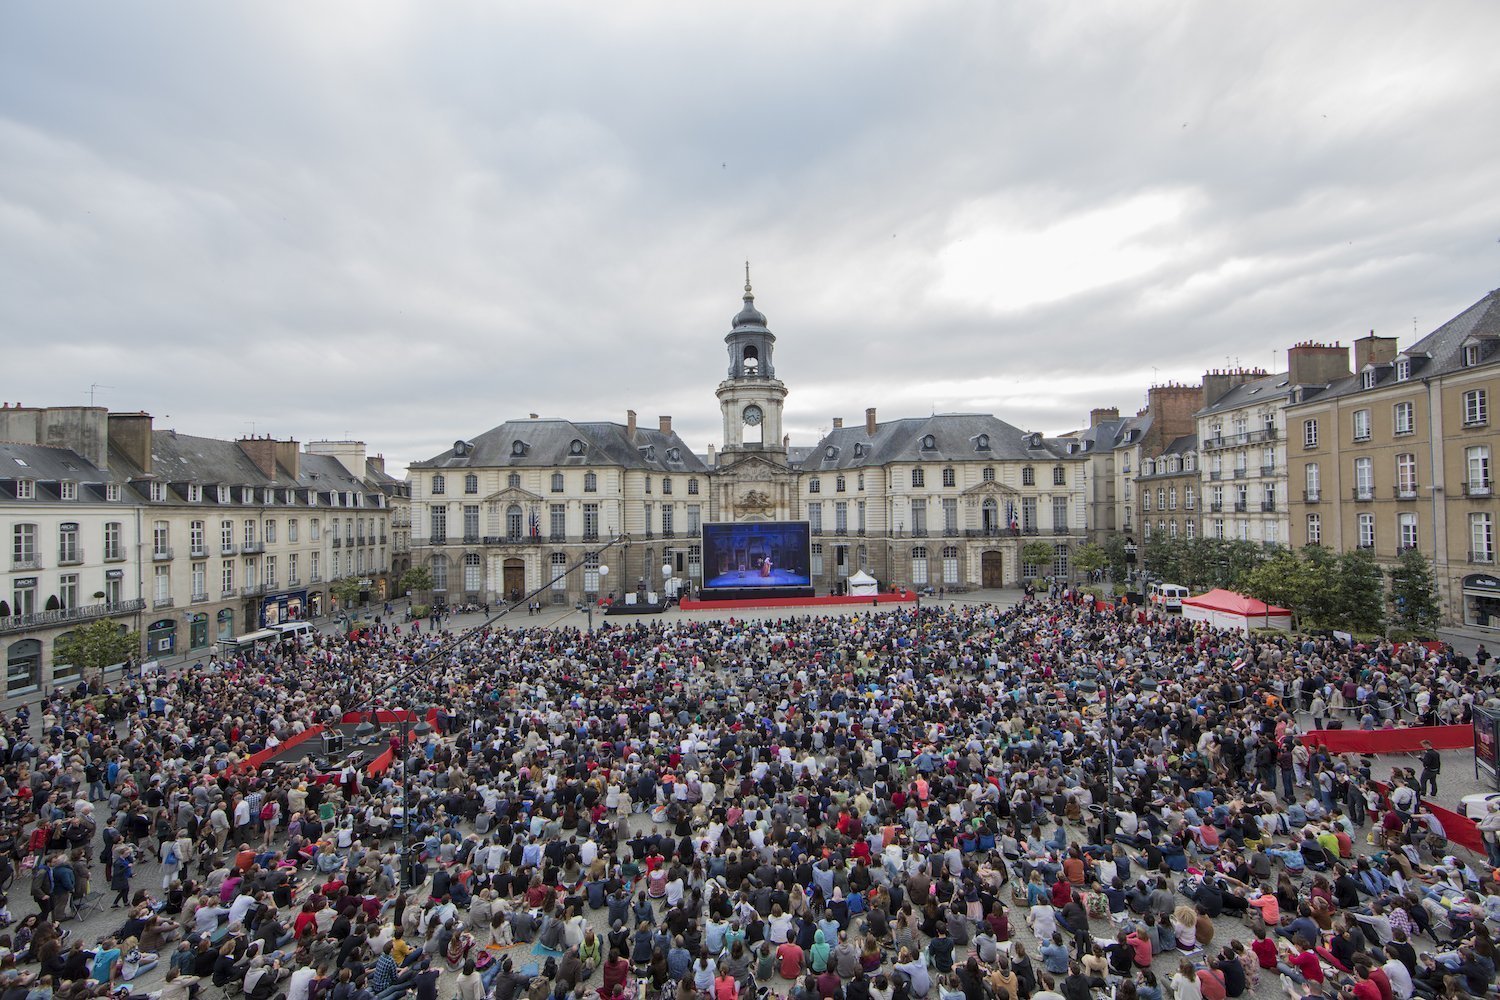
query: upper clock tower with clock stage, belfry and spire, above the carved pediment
717 261 786 463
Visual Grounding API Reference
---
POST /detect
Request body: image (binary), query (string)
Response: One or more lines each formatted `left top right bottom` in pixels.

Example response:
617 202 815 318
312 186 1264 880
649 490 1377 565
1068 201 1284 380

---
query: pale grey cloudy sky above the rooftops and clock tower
0 0 1500 476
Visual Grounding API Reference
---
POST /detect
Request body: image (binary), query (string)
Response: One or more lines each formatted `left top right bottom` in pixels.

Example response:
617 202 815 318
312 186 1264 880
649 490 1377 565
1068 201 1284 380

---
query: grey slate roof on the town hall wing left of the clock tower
410 418 708 472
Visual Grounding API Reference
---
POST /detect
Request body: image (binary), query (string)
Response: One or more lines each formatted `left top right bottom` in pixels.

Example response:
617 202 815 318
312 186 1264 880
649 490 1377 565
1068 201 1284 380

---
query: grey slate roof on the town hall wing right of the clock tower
803 414 1083 472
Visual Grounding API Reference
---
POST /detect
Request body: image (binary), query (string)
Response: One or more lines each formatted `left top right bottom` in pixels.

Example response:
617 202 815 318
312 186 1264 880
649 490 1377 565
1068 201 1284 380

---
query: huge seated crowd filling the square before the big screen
0 595 1500 1000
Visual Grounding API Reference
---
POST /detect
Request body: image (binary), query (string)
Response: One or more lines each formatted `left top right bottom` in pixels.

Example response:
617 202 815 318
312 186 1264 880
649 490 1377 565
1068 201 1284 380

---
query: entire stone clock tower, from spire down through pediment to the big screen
714 262 797 520
